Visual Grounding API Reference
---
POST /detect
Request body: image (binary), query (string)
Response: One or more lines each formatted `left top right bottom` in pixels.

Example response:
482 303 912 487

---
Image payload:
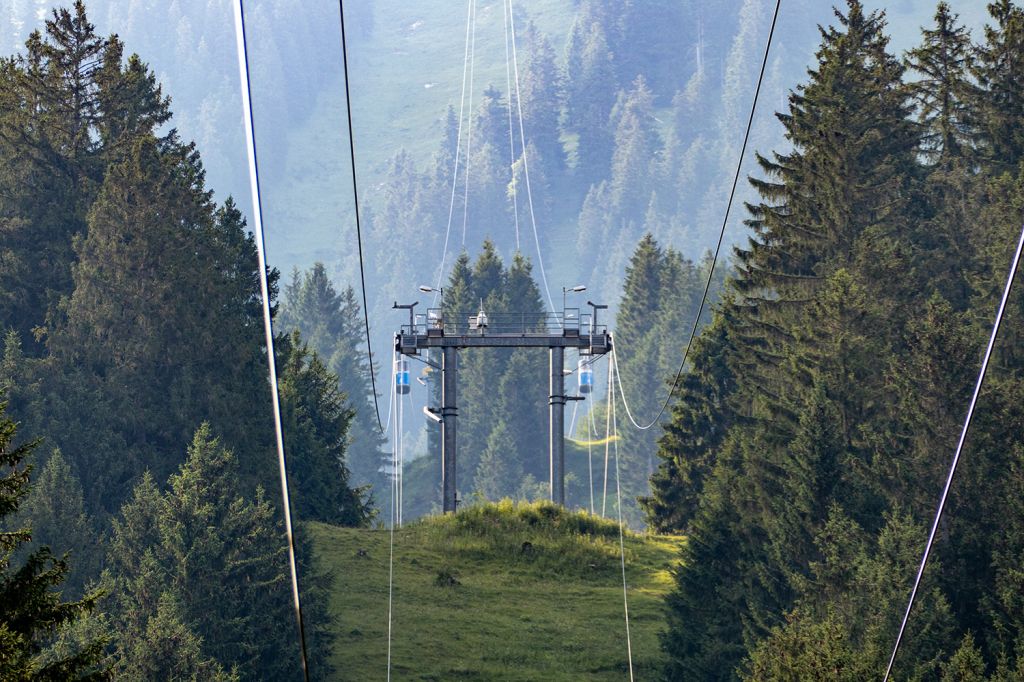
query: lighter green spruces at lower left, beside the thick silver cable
105 425 330 679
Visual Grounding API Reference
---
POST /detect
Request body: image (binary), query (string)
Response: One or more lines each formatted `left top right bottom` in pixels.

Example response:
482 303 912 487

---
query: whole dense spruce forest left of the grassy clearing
0 2 360 680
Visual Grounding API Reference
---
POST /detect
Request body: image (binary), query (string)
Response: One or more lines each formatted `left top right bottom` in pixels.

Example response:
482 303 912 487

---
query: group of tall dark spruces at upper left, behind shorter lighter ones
0 2 288 519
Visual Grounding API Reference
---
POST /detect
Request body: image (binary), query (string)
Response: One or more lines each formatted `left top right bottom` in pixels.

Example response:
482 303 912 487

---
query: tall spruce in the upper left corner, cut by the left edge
0 1 109 355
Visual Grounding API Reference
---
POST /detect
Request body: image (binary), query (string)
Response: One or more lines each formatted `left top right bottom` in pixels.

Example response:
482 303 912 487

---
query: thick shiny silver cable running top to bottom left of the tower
234 0 307 682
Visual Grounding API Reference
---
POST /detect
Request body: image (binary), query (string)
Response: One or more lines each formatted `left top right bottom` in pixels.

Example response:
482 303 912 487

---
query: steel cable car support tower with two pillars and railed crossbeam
394 301 611 512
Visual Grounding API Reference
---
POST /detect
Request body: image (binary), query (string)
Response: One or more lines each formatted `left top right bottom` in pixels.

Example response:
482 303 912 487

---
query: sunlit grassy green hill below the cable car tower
312 501 683 680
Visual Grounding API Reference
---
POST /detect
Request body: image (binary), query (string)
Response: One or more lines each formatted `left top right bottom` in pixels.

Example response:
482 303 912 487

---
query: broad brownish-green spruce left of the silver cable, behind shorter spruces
40 137 274 510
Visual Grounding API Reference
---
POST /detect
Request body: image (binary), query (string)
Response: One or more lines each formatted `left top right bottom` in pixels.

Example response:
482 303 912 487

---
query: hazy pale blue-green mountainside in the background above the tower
0 0 984 462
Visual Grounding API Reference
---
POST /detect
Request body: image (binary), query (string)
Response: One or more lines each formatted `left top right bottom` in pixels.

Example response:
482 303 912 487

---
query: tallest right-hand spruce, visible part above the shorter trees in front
736 0 915 385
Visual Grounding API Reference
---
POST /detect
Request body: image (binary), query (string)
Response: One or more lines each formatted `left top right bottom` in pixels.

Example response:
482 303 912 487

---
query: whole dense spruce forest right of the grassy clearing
644 0 1024 680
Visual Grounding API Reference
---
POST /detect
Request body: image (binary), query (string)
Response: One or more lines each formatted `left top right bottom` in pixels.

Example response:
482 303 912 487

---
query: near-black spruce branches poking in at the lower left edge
0 402 109 680
